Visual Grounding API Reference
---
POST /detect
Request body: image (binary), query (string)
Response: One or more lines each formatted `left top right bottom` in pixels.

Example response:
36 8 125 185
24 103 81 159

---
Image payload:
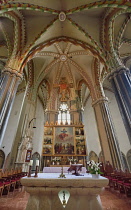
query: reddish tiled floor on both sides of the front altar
0 189 131 210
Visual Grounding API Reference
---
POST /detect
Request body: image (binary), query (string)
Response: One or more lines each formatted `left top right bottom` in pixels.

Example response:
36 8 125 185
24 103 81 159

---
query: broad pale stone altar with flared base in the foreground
21 173 108 210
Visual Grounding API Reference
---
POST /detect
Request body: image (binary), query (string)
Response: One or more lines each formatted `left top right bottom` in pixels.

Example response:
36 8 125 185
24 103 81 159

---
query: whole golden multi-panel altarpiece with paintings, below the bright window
42 125 87 166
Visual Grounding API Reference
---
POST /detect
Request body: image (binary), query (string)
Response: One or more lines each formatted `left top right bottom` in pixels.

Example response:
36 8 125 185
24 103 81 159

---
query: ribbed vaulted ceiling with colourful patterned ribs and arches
0 0 131 108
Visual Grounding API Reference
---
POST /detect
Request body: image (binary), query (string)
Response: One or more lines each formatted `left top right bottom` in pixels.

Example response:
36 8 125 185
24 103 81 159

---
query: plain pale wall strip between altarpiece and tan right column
83 98 101 156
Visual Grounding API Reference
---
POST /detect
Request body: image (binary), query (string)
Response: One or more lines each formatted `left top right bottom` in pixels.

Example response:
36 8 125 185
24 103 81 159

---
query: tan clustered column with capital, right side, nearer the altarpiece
92 97 123 168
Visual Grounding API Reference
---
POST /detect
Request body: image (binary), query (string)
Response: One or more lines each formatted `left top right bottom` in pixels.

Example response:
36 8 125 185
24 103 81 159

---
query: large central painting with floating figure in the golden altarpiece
54 127 75 155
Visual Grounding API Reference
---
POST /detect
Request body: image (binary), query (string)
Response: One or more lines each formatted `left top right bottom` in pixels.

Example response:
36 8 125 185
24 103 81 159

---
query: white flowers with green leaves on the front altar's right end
87 160 102 174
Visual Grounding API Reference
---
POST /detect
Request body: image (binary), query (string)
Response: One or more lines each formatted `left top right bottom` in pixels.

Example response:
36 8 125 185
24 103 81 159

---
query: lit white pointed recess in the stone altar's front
58 190 70 208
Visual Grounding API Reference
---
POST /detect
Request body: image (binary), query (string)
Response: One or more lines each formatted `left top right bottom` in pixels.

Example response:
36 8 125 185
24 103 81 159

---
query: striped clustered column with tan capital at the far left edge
0 69 22 144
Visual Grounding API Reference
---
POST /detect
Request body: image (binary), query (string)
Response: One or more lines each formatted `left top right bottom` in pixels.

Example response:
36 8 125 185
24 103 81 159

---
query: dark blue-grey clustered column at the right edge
109 67 131 143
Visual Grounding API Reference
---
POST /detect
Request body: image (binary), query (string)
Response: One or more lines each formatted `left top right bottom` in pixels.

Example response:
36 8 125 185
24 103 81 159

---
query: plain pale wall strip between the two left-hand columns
1 92 24 156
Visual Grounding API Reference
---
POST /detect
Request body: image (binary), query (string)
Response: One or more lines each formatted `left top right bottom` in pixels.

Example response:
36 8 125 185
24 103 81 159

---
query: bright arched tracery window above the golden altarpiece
58 103 70 125
